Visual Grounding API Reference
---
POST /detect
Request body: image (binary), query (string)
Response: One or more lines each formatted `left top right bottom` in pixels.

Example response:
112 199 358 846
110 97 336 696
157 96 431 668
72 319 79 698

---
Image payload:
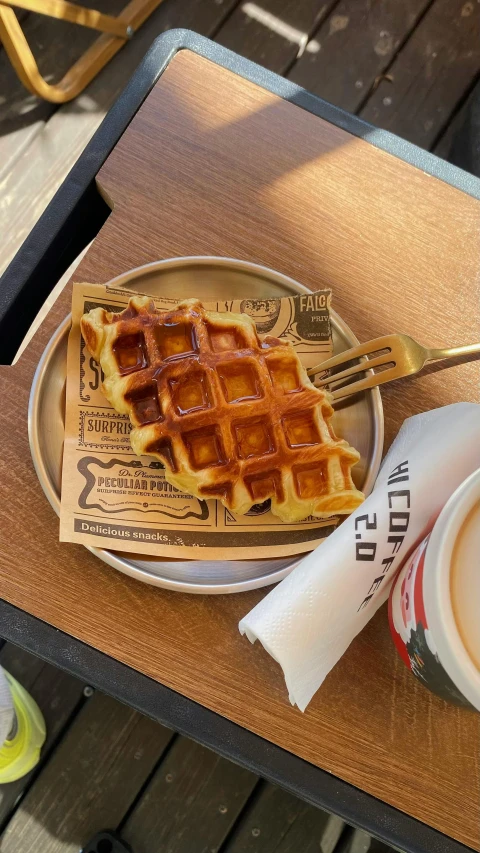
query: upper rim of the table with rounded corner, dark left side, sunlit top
0 29 480 365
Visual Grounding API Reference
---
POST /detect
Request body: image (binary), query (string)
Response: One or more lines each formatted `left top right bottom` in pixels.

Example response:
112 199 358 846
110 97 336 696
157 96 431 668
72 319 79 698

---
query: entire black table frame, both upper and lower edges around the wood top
0 30 480 853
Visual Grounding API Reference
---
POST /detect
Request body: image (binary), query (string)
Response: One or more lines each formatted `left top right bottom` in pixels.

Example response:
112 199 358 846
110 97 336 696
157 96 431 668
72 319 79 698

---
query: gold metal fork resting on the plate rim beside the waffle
307 335 480 400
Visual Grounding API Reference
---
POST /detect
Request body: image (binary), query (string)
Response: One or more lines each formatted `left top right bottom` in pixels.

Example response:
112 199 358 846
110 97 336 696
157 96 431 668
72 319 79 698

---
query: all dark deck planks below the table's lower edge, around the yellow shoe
0 644 402 853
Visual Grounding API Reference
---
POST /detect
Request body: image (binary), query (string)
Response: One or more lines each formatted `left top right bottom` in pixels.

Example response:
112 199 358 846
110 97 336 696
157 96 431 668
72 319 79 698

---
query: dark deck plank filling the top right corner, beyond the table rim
360 0 480 148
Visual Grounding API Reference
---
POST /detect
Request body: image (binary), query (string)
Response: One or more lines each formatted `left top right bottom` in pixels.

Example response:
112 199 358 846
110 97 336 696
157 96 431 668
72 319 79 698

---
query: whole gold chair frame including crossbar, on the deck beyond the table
0 0 162 104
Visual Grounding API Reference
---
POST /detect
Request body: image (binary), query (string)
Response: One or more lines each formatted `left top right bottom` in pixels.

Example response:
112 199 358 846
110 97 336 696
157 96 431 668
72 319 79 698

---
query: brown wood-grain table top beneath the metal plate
0 51 480 848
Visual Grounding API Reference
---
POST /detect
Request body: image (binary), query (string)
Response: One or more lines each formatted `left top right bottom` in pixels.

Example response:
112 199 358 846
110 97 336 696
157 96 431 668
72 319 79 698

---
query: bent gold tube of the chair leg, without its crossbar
0 0 166 104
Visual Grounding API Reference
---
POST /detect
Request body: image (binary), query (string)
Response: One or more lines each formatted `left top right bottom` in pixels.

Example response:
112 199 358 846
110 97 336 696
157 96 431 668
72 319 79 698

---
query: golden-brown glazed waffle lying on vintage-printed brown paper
81 296 364 522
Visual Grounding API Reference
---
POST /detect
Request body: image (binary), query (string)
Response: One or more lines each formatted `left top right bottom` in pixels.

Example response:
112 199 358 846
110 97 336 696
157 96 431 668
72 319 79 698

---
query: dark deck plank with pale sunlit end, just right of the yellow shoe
1 693 173 853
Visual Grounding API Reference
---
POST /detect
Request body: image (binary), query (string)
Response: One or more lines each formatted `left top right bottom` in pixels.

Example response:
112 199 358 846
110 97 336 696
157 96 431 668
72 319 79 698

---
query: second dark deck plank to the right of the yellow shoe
122 738 258 853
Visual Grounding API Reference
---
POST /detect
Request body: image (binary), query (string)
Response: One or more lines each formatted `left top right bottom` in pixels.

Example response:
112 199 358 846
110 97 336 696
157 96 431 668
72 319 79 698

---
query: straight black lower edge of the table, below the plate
0 599 472 853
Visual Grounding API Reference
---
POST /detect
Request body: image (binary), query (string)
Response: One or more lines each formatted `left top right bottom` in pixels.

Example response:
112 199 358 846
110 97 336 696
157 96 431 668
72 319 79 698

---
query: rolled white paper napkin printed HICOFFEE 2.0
239 403 480 711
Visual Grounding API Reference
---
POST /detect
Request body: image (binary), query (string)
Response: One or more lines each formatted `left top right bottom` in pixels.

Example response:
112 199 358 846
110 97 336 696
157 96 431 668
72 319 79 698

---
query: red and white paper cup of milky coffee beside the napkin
389 470 480 711
